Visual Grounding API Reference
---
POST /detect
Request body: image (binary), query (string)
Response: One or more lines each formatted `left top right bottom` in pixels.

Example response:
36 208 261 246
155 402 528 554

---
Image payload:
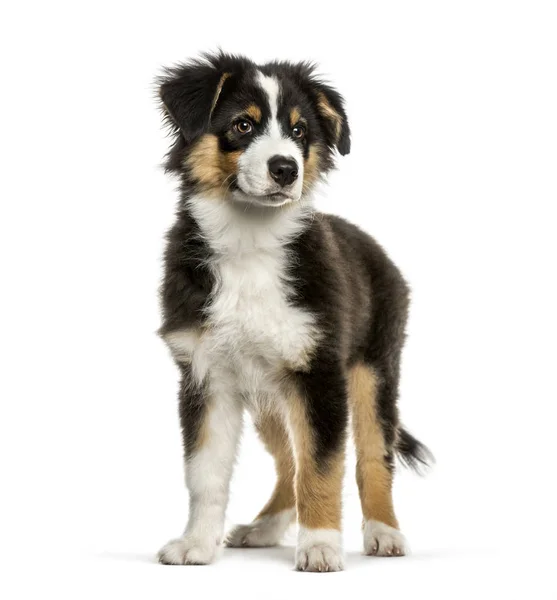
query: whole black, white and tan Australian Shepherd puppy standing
159 54 428 571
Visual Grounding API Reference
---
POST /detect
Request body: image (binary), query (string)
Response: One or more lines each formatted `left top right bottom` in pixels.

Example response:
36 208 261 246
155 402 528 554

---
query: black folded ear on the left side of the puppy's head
159 61 231 146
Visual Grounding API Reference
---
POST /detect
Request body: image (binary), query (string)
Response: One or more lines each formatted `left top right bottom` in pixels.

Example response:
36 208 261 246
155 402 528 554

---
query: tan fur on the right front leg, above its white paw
288 384 344 530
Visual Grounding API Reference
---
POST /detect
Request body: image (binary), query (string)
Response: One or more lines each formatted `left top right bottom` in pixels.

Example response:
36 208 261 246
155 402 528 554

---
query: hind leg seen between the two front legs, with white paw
226 414 296 548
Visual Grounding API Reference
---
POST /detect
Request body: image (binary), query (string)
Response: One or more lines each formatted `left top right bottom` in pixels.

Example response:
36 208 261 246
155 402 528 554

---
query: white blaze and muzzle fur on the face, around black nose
238 72 304 200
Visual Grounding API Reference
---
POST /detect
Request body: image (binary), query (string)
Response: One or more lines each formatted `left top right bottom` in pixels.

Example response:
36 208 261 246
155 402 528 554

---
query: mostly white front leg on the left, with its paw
159 365 242 565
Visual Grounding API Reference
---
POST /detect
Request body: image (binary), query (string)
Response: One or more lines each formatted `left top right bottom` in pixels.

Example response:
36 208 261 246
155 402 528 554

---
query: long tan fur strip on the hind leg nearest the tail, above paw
349 364 398 529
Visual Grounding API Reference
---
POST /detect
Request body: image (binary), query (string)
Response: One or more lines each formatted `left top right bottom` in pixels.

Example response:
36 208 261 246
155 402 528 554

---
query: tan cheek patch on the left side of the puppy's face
186 133 242 190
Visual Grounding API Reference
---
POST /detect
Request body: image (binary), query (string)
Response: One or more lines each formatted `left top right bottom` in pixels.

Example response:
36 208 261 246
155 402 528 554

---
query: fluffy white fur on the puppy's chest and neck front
166 198 317 407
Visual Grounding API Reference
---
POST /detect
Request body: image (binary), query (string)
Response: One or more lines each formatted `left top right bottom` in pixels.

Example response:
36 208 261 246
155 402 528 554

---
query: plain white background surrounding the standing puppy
0 0 557 599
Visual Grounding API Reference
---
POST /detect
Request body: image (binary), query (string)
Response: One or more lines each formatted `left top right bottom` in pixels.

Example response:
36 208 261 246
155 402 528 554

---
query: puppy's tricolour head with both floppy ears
159 54 350 206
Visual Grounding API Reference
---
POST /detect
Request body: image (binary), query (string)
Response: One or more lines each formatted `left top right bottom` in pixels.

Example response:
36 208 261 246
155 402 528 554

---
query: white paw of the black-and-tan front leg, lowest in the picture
296 527 344 573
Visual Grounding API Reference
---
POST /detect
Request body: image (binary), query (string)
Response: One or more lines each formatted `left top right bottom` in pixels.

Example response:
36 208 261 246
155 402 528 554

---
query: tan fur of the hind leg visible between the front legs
256 414 296 519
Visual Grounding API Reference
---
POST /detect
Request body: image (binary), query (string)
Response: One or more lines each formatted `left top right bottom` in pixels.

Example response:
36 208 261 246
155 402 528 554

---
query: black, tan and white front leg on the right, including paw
288 367 348 571
